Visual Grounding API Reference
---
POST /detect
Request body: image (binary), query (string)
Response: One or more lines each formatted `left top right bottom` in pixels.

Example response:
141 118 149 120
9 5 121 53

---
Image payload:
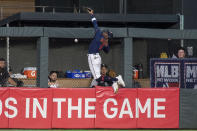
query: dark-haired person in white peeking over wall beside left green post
48 71 59 88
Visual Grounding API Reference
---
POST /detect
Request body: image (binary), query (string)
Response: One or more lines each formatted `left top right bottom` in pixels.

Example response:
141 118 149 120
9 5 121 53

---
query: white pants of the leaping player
88 53 101 86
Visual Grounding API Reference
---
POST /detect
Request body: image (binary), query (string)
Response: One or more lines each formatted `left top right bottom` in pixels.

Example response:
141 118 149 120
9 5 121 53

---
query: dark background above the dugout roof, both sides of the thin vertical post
35 0 181 14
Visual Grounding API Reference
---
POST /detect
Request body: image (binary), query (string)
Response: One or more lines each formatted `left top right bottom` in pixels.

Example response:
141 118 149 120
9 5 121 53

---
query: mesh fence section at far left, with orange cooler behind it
0 37 37 87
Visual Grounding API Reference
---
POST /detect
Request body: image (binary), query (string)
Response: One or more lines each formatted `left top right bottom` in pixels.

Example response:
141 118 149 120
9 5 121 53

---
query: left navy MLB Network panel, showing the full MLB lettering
151 59 181 88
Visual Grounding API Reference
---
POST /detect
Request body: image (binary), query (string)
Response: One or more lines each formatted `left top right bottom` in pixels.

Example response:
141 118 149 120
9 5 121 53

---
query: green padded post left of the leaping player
37 37 49 88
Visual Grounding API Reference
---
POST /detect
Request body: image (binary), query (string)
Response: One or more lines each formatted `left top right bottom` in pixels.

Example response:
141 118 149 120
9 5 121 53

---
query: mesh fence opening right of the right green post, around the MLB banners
133 38 197 87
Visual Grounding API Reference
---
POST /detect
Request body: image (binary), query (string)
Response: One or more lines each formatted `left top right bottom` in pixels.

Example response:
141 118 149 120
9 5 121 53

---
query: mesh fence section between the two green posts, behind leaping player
49 38 123 88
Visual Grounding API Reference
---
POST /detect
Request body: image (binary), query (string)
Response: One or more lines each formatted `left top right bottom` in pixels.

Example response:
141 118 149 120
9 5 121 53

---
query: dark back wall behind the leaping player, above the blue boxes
49 39 123 74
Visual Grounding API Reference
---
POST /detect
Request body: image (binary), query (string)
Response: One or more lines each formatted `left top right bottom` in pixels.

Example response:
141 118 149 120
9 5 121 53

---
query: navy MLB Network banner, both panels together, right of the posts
150 58 197 88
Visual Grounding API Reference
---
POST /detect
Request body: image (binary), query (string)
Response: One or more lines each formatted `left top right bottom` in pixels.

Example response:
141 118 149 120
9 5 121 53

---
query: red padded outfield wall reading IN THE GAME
0 87 179 129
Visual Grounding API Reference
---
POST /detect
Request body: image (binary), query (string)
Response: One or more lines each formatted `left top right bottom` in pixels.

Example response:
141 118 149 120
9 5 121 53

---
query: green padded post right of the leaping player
123 38 133 87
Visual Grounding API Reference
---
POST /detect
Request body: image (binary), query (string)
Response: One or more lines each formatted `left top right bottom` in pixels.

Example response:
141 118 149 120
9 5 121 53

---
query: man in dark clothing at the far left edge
0 58 17 87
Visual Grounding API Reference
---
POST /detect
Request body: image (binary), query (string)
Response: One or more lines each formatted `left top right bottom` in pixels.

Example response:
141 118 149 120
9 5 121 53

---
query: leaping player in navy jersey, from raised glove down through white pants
87 9 113 87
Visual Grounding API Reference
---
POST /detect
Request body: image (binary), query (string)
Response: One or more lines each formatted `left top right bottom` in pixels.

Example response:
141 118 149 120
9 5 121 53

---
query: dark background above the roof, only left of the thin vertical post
35 0 119 13
